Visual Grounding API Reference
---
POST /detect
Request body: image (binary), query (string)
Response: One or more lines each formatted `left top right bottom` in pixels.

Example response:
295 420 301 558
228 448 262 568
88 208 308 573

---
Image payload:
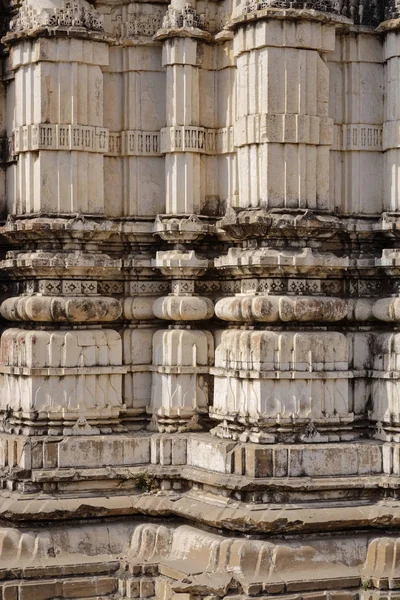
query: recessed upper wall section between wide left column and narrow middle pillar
104 9 166 218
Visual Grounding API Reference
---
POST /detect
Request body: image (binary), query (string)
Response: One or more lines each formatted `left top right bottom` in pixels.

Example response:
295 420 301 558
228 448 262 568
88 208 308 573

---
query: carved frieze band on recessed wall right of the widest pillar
332 123 383 152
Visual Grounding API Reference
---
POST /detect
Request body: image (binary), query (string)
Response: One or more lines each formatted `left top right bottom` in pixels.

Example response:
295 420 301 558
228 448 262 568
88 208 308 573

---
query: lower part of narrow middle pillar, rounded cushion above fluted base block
151 241 214 432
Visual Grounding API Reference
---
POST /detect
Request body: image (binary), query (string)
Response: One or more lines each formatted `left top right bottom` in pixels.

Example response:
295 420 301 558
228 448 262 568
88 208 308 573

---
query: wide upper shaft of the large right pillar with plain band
234 13 335 210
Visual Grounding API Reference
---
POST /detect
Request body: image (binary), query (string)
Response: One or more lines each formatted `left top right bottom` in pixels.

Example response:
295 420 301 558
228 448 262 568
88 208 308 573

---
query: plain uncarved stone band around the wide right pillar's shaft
234 114 333 147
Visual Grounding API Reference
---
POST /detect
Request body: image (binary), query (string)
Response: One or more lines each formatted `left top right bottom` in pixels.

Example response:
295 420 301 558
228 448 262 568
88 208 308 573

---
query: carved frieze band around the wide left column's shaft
14 123 109 154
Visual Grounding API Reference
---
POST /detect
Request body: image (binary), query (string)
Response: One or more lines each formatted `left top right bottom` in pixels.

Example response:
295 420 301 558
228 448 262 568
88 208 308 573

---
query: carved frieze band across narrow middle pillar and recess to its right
161 125 234 154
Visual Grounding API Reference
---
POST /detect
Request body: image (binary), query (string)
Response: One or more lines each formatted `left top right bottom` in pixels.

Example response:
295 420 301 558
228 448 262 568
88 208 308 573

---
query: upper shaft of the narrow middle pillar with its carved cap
155 1 215 215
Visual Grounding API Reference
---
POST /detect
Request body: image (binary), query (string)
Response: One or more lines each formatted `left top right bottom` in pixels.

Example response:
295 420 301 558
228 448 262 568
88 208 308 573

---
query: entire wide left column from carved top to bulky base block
0 0 126 435
